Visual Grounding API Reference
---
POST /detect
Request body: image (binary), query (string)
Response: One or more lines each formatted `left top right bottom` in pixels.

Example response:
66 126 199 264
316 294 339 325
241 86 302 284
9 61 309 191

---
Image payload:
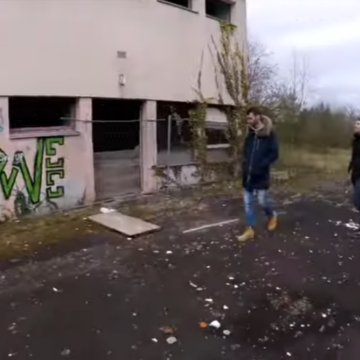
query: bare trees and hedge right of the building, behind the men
247 41 359 151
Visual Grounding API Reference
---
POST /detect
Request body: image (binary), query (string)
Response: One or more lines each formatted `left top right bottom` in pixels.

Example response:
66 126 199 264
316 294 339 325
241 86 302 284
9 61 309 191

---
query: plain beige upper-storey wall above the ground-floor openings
0 0 246 101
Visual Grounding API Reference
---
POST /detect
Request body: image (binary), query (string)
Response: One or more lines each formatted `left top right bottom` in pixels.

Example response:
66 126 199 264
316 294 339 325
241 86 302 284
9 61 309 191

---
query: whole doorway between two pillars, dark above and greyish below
93 99 142 200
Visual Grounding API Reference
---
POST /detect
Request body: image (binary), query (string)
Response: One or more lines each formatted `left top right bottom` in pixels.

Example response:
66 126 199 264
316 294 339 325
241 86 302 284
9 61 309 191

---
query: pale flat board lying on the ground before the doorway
89 211 160 237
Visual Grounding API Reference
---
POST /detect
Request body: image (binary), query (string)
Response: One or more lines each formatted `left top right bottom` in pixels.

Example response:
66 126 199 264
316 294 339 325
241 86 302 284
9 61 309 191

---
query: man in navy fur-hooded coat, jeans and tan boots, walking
238 107 279 242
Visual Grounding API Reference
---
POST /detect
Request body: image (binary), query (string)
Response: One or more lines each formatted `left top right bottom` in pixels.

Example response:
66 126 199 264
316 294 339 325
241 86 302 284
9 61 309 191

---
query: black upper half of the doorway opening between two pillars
92 99 142 152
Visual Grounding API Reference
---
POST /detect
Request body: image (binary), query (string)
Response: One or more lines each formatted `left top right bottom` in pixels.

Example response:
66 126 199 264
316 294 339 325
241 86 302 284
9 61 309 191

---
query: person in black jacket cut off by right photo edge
348 119 360 236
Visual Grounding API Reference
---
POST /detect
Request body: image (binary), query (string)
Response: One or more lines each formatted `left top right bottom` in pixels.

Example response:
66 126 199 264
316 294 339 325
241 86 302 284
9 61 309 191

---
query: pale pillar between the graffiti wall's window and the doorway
74 98 95 204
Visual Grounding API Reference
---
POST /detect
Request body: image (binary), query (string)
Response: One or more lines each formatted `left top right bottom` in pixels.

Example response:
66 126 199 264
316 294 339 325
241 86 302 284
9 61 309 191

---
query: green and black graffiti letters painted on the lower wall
0 136 65 214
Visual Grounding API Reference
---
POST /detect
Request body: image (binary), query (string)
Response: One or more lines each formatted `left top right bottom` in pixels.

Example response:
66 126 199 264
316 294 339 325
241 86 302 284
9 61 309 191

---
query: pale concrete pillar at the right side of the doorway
140 101 157 194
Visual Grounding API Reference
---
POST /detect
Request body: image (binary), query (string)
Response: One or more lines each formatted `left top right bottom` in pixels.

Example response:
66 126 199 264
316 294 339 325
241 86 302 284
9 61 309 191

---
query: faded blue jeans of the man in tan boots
243 190 276 227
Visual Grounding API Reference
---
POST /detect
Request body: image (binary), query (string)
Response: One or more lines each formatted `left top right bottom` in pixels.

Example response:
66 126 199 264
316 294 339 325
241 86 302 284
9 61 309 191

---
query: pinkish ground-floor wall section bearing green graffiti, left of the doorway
0 98 95 220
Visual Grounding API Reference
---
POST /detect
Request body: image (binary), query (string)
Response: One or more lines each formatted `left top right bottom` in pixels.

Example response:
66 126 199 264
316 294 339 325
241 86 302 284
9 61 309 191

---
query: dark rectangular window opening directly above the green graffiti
9 97 76 130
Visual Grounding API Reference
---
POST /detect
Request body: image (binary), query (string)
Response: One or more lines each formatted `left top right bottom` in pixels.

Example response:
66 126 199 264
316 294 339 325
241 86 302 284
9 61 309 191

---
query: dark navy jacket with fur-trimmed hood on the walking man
242 116 279 191
